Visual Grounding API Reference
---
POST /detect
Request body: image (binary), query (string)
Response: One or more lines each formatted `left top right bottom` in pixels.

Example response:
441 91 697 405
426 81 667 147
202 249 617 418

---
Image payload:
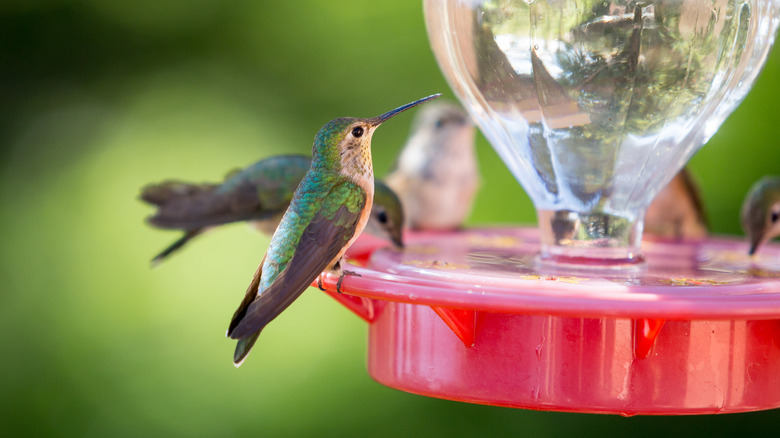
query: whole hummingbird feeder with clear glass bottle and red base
316 0 780 415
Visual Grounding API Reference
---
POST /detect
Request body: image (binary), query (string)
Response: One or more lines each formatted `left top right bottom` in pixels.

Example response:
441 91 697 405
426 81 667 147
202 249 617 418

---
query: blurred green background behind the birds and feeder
0 0 780 437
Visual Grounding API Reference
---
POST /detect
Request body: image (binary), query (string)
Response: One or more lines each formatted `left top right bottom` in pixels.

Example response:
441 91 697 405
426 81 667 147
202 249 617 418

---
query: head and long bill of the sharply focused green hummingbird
312 94 441 180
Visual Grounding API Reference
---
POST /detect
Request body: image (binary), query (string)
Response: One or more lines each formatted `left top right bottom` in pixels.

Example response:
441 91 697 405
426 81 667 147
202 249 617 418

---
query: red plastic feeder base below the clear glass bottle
314 228 780 415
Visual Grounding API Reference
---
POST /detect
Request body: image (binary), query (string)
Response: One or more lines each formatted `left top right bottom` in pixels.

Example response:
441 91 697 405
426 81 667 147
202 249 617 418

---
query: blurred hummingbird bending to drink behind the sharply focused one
140 155 403 264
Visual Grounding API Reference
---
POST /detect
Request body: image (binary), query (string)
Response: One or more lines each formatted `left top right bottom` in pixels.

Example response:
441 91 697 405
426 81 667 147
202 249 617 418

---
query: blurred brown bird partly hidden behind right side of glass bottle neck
644 168 709 240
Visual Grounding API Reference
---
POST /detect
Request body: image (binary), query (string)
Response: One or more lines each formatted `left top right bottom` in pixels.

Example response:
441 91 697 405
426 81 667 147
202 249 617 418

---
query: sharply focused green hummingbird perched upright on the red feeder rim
227 94 441 366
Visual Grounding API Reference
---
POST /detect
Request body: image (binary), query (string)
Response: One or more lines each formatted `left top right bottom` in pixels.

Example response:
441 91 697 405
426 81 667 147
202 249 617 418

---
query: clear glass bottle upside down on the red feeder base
424 0 780 264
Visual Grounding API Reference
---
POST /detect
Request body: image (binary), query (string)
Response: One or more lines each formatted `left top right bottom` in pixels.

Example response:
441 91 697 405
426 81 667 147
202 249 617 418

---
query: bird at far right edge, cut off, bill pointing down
741 176 780 255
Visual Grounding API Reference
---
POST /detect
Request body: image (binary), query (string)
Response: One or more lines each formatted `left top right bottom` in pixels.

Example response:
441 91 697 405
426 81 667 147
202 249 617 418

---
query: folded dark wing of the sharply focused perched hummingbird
228 183 366 339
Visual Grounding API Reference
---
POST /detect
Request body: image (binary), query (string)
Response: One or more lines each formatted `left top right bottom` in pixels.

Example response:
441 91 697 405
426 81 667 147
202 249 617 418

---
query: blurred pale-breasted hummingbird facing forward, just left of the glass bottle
385 102 479 229
